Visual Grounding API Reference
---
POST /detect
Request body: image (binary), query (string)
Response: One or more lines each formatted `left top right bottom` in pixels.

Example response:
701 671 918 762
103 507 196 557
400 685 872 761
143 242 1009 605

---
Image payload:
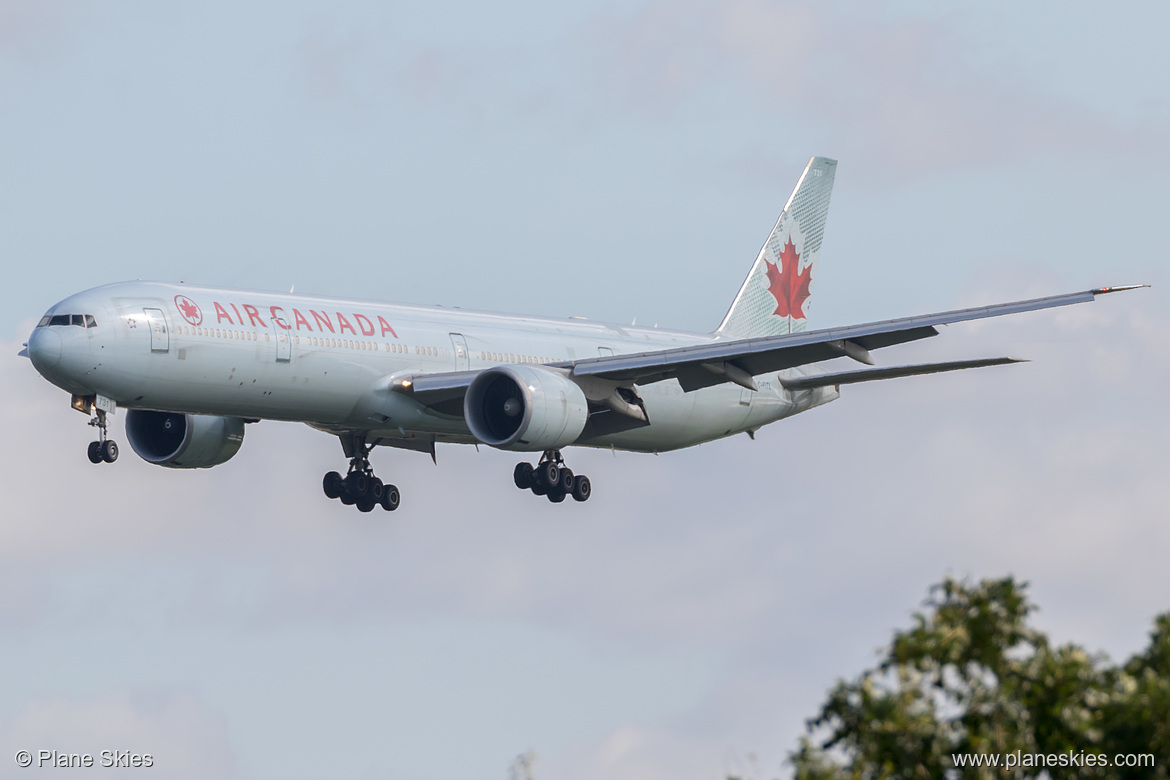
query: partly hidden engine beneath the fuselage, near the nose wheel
126 409 243 469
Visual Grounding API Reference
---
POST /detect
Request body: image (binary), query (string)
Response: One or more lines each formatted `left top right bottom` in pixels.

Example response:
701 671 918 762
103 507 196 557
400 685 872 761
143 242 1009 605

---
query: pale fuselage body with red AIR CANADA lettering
29 282 838 451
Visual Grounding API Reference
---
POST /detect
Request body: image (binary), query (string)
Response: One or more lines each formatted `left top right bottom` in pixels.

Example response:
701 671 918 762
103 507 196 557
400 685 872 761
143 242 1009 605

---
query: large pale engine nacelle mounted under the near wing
463 365 589 453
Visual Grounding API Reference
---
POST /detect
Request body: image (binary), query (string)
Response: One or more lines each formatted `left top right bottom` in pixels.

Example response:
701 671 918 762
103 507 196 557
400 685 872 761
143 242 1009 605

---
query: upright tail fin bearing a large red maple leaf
715 157 837 338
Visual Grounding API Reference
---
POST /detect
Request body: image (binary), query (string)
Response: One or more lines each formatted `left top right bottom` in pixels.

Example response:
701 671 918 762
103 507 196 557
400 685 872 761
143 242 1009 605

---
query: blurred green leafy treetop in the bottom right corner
790 578 1170 780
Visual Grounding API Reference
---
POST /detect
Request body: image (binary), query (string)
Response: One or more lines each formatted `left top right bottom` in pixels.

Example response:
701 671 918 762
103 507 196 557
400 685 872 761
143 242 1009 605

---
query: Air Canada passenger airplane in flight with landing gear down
20 157 1147 512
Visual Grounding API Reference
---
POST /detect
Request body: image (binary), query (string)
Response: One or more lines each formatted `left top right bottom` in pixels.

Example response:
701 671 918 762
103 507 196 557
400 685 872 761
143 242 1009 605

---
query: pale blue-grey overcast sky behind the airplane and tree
0 0 1170 780
